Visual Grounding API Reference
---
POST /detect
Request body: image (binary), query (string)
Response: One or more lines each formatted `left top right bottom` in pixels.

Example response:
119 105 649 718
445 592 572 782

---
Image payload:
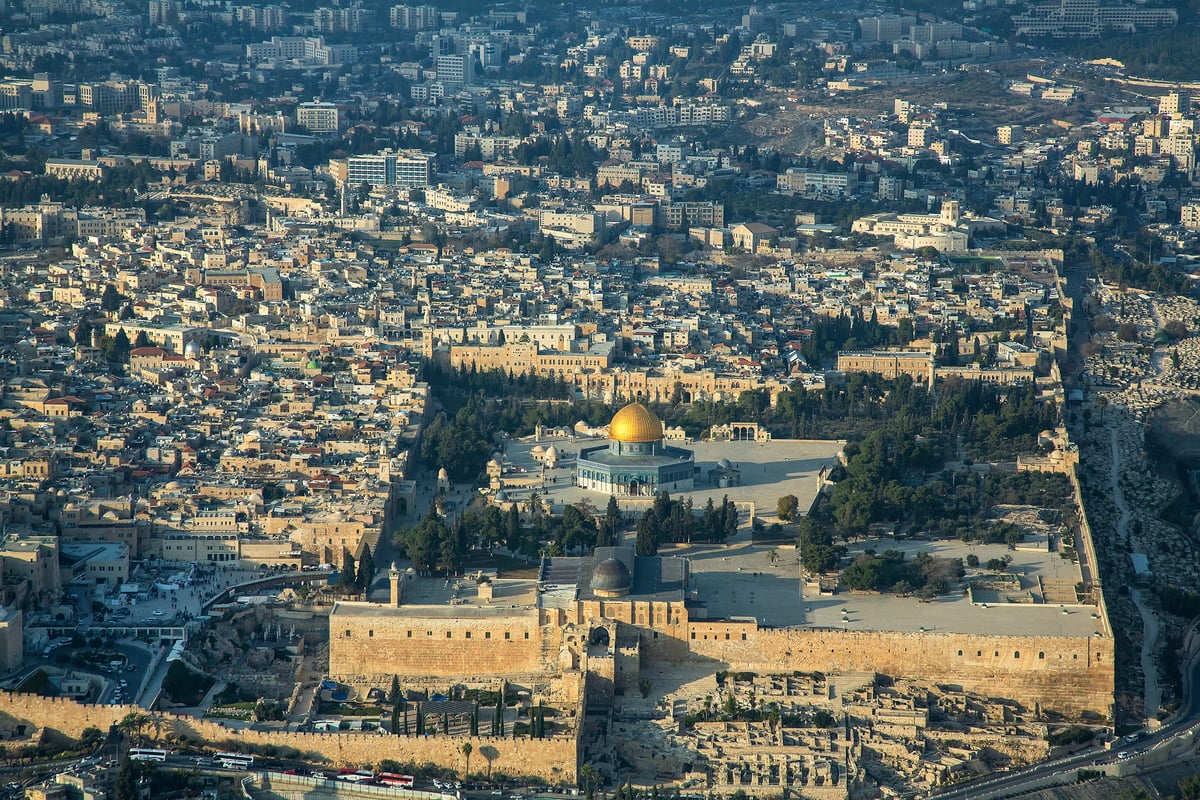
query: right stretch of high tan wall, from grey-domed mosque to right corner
689 622 1115 717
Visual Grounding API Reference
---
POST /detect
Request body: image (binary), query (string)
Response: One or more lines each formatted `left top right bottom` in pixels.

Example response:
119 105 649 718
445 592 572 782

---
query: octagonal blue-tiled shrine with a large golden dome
575 403 696 497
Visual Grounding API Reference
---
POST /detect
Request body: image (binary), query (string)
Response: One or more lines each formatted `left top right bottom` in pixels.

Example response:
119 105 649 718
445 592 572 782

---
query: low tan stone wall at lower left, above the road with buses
0 692 577 784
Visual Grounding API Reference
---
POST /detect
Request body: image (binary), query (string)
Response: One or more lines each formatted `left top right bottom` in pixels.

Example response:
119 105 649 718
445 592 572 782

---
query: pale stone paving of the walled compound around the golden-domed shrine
472 437 1103 637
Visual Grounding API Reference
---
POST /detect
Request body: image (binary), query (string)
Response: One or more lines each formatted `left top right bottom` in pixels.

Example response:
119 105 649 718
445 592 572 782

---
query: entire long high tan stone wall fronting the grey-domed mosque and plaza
330 599 1115 717
